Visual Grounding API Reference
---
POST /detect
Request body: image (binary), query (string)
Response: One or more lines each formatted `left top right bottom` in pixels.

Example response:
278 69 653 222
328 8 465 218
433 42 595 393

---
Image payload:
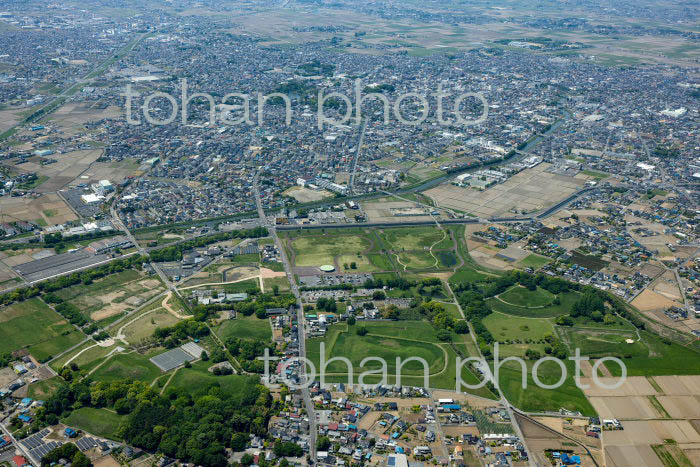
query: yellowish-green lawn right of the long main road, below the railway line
291 233 372 267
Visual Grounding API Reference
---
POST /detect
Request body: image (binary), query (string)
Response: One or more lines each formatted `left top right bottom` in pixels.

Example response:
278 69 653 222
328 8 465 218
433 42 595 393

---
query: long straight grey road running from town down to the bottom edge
253 171 316 462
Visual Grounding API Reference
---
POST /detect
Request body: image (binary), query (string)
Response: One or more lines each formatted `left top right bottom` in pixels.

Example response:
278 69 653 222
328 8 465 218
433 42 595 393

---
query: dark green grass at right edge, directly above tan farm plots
605 331 700 376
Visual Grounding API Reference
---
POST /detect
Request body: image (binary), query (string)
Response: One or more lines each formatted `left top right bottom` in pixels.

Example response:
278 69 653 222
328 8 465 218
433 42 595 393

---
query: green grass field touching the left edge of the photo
0 298 85 361
